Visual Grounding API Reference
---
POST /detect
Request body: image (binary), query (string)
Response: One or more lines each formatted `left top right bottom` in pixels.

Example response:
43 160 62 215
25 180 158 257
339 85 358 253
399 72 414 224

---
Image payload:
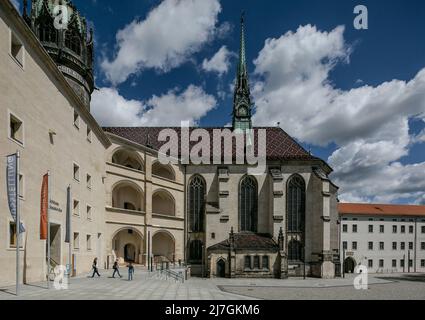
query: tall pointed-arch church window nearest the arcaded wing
189 176 205 232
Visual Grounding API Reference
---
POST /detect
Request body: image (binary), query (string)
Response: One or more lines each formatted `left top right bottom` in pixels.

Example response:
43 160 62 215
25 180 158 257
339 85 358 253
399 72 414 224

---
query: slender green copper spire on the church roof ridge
233 13 252 130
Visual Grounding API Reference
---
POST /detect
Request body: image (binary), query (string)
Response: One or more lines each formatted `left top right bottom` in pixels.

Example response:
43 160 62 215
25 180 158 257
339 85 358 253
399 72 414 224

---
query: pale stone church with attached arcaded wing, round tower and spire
0 0 340 283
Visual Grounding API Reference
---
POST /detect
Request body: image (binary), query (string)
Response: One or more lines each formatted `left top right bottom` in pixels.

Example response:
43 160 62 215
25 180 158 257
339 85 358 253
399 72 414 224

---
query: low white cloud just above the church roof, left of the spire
91 85 217 127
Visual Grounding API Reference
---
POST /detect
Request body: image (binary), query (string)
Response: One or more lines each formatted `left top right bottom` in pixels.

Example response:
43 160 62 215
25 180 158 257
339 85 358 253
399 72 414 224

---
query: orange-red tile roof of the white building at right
338 203 425 217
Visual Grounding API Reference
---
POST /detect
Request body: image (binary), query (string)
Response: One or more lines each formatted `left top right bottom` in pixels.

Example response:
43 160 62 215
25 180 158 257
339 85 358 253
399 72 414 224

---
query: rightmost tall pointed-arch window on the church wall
286 175 305 232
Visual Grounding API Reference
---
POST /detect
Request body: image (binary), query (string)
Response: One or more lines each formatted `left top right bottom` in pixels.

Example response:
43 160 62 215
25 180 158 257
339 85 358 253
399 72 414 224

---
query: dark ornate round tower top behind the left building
23 0 94 109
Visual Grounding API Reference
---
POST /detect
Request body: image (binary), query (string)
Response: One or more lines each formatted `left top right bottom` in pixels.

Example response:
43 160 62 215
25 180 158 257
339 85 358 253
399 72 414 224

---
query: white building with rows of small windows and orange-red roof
338 203 425 273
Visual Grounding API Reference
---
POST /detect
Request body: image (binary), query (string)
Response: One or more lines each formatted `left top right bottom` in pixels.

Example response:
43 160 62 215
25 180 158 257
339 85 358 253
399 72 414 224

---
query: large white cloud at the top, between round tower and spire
101 0 221 84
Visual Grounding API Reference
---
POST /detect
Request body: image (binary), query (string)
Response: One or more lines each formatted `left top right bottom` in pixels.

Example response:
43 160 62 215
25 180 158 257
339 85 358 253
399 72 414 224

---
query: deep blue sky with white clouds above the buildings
15 0 425 203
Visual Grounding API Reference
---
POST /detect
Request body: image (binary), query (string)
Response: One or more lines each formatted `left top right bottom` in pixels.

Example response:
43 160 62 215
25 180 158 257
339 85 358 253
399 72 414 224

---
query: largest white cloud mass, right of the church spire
253 25 425 201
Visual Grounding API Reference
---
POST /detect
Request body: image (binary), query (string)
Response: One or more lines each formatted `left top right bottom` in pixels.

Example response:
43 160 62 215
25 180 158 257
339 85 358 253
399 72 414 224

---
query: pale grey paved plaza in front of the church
0 269 425 300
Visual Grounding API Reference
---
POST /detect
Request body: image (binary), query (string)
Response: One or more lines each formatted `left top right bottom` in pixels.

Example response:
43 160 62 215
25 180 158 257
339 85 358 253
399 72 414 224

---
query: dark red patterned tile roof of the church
103 127 324 162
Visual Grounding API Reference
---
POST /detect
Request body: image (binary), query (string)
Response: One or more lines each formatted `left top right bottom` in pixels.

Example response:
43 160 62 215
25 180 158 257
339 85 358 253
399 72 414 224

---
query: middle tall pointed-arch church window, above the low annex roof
239 176 258 232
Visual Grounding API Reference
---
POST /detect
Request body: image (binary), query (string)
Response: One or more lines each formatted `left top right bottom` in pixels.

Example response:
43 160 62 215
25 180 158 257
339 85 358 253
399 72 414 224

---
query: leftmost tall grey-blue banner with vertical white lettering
6 154 25 233
